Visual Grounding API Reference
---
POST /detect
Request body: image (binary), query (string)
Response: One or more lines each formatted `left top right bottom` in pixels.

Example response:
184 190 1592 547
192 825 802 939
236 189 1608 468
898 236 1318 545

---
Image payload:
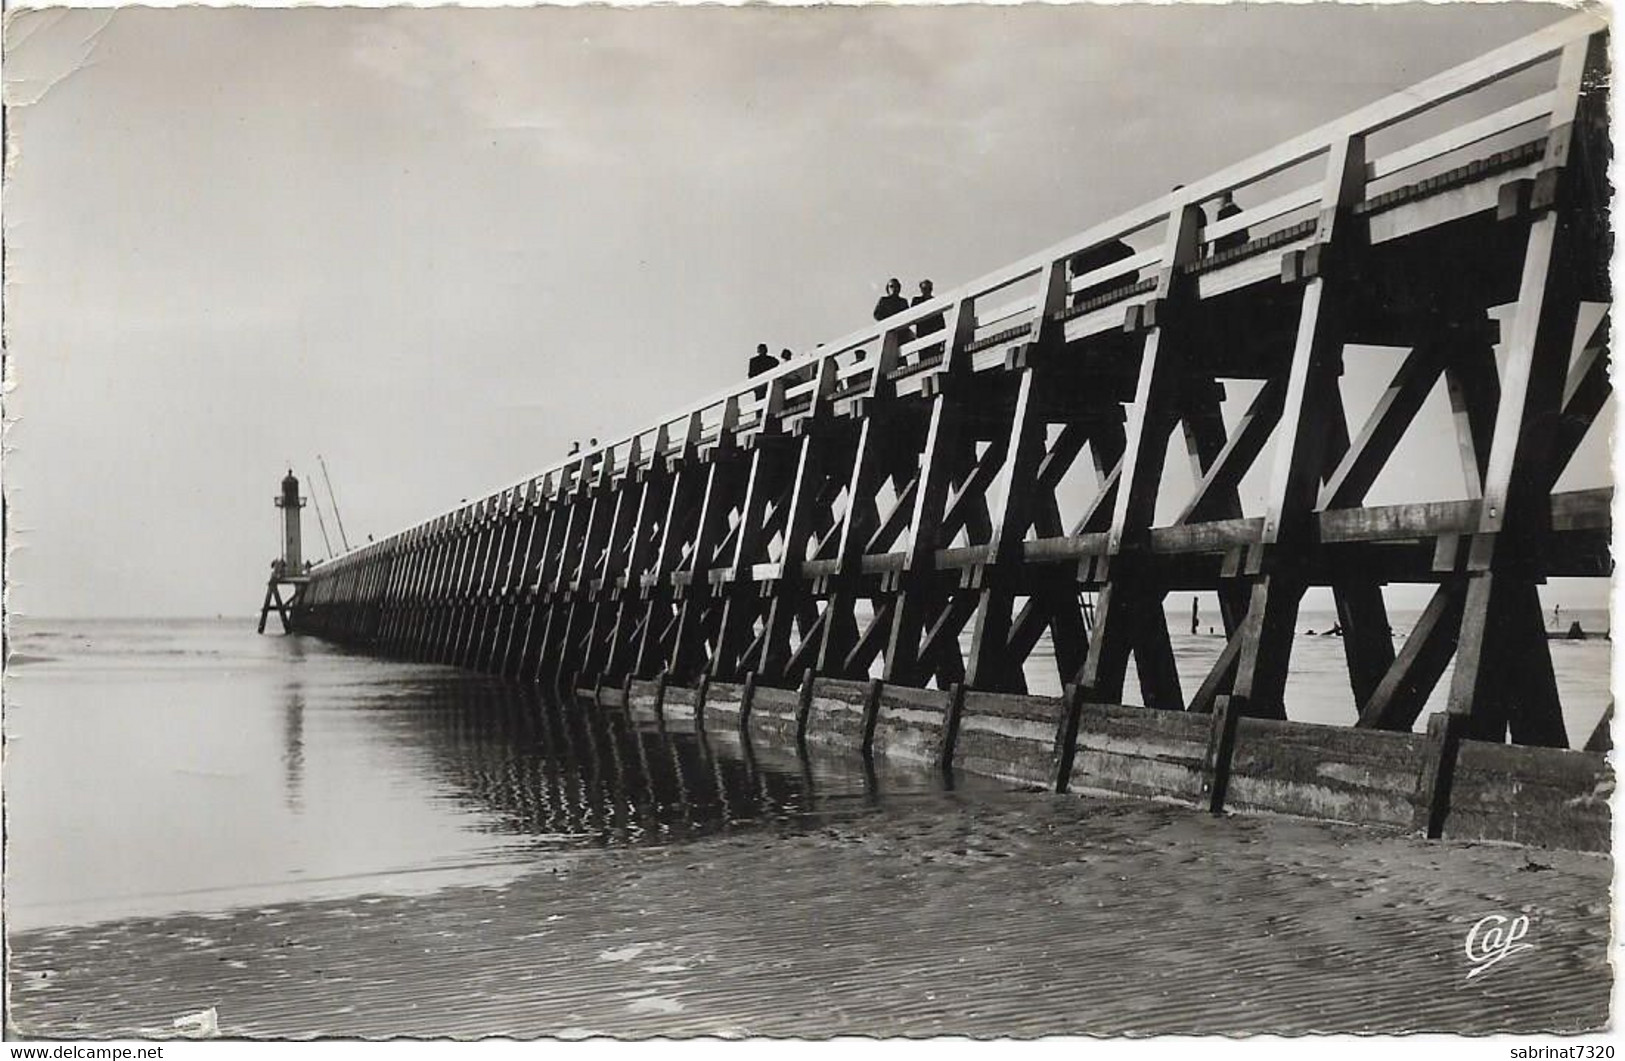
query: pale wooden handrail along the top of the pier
313 11 1607 569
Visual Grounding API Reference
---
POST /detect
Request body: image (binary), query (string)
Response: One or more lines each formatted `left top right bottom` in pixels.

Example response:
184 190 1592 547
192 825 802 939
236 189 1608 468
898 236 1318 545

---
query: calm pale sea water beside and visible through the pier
3 611 1610 933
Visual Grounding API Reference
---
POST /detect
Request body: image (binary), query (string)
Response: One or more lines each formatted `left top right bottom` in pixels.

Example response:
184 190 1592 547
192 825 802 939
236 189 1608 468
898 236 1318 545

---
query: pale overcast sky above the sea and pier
5 3 1607 616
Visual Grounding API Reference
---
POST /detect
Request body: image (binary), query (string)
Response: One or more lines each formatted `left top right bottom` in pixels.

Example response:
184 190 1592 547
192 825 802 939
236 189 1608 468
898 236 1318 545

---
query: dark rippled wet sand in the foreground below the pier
8 793 1612 1038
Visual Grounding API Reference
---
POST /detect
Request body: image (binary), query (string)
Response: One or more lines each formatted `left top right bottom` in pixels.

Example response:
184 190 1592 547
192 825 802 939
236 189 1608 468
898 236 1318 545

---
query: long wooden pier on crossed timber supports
279 15 1612 848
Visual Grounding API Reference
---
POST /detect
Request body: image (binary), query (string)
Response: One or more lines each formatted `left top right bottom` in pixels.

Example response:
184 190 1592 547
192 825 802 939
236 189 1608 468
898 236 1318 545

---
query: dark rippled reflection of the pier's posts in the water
396 678 903 845
